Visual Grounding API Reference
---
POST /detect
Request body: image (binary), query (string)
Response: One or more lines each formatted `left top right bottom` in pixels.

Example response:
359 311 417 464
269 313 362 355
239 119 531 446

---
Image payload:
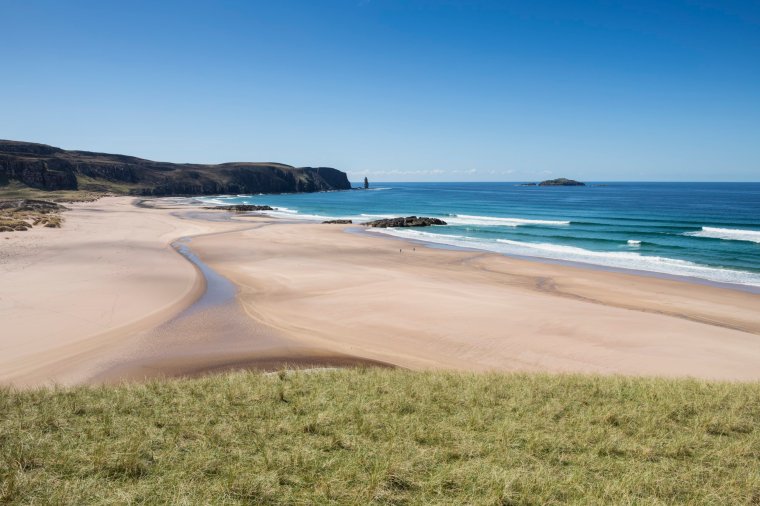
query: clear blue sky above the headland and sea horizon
0 0 760 181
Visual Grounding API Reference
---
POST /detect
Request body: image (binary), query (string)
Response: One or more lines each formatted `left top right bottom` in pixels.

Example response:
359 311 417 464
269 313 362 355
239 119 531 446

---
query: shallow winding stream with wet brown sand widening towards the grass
91 233 385 383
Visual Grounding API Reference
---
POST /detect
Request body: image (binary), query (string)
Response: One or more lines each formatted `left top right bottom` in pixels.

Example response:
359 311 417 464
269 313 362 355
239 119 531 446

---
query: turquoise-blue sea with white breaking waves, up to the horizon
203 183 760 287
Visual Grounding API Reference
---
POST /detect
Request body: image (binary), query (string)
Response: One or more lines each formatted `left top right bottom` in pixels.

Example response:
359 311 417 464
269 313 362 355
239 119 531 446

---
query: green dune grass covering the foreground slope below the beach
0 369 760 504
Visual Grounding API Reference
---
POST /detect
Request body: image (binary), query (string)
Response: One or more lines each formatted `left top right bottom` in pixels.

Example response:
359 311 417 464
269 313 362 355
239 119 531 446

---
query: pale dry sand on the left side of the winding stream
0 197 246 386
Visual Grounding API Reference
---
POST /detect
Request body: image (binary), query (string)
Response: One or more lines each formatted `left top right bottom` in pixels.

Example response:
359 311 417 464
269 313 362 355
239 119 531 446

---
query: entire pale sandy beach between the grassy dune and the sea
0 197 760 386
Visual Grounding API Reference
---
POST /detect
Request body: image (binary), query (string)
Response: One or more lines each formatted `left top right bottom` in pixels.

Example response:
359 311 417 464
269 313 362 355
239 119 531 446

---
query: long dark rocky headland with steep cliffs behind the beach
0 140 351 195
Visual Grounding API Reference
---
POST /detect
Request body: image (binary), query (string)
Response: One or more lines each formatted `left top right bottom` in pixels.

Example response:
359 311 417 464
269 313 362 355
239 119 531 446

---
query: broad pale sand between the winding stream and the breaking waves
193 223 760 380
